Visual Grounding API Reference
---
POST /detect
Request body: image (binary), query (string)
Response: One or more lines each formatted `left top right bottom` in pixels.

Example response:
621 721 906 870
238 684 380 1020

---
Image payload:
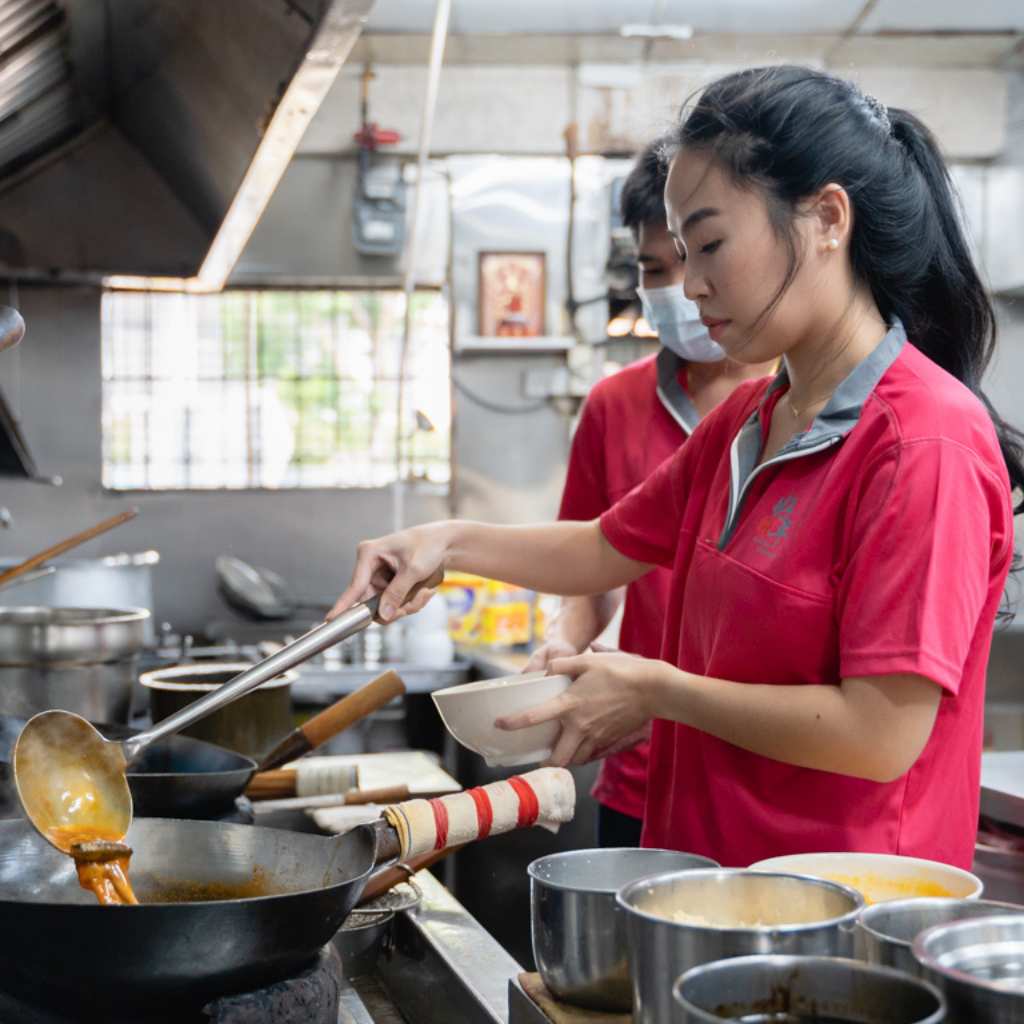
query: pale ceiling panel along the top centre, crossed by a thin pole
366 0 863 35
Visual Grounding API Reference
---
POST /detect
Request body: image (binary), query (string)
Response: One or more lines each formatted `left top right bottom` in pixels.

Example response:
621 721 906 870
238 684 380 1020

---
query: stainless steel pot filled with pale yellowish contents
617 868 864 1024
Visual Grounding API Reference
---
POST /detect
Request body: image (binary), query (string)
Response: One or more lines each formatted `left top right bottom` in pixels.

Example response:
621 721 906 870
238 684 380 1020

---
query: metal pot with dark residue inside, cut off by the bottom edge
673 956 945 1024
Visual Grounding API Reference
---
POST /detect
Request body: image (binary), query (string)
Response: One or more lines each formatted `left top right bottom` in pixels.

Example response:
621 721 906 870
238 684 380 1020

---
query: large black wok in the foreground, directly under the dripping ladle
0 818 380 1019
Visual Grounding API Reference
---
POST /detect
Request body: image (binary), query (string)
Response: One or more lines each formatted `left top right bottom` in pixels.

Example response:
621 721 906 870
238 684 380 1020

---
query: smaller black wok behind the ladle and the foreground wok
0 716 256 818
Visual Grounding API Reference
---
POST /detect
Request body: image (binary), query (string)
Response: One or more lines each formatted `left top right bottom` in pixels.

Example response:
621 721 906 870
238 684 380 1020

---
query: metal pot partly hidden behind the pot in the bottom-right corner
856 899 1022 977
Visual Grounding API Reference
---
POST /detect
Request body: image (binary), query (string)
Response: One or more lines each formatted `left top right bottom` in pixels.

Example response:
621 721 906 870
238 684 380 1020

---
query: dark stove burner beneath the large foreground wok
0 944 343 1024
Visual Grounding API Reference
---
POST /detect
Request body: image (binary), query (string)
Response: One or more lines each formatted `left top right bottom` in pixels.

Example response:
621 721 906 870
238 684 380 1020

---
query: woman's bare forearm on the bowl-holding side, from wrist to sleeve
647 663 941 782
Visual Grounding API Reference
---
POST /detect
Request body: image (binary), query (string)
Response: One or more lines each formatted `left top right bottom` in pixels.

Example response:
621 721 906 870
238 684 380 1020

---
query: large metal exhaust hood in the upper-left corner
0 0 374 281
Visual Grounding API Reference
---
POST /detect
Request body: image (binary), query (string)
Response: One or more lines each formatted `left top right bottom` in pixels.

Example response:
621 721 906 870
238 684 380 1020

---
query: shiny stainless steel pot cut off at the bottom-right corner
913 912 1024 1024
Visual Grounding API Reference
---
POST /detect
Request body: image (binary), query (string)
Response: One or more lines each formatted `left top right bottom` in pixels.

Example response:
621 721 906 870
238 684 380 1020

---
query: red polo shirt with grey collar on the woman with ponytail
601 325 1013 867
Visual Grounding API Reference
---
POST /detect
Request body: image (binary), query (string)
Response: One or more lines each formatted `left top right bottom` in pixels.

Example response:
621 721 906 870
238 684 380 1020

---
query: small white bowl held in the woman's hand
431 672 570 768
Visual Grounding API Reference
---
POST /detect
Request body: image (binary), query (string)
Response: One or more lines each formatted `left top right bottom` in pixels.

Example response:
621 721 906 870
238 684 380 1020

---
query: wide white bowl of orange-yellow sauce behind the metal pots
751 853 984 903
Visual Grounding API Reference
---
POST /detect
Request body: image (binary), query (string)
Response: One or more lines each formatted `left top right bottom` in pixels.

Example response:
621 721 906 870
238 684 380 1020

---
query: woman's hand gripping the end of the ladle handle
327 522 451 623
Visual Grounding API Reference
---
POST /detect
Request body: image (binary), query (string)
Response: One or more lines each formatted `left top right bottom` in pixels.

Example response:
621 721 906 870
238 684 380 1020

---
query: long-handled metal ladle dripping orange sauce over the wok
13 570 443 853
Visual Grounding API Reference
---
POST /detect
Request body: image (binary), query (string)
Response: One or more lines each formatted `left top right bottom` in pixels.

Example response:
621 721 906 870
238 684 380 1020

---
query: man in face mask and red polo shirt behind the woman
527 142 774 847
